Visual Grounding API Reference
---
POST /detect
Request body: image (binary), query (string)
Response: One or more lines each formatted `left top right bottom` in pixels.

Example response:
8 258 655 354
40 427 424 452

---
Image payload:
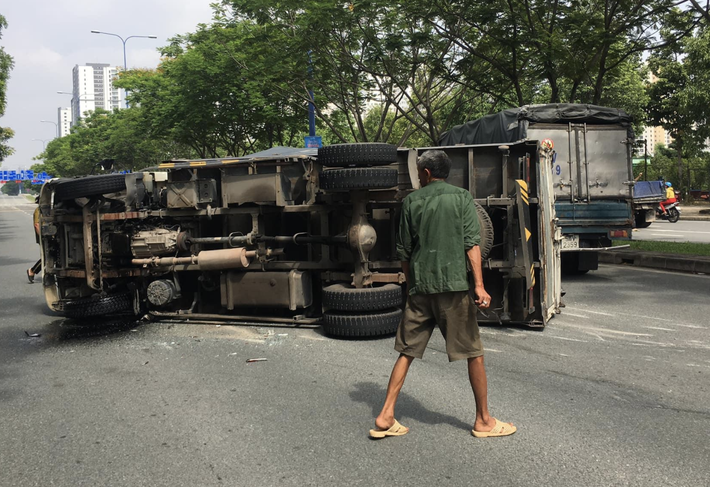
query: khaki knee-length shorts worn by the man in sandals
394 291 483 362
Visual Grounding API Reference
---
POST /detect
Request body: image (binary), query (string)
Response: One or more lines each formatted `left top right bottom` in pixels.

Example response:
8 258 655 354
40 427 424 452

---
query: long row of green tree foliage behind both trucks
34 0 710 181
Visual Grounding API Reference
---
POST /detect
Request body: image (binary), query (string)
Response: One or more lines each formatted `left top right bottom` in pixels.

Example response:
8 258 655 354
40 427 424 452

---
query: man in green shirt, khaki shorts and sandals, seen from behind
370 150 517 438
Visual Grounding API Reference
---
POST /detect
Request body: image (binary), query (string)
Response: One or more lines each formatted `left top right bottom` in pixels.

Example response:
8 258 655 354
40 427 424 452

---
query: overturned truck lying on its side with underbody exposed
40 142 559 336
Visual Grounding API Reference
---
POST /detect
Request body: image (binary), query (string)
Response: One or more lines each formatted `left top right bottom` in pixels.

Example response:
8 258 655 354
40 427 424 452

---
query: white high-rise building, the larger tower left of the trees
72 63 126 125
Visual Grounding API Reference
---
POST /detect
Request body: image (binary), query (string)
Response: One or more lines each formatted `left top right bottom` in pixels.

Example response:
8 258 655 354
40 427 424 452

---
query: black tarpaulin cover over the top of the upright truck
439 103 633 146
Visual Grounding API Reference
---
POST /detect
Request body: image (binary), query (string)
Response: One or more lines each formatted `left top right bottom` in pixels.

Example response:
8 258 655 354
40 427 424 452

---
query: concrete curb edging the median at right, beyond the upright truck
599 250 710 274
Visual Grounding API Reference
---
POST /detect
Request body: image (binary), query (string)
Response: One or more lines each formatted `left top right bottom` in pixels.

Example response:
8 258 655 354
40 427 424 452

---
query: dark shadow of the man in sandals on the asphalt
350 382 473 431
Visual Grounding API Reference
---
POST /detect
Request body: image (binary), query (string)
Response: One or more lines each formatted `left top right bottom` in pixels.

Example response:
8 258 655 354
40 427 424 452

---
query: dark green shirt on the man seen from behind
397 181 481 294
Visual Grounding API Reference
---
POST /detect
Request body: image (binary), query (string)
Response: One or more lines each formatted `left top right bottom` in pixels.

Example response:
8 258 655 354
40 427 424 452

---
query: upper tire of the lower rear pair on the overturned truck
323 284 402 311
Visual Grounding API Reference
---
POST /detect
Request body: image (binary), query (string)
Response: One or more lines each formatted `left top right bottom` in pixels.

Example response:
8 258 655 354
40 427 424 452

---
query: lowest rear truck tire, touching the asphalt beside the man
323 309 402 337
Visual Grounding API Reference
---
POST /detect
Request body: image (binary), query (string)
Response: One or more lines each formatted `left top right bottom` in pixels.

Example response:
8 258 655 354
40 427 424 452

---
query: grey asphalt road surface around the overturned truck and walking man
0 199 710 487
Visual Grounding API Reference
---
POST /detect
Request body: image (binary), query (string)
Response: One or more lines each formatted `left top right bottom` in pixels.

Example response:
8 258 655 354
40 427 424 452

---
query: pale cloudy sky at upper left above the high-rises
0 0 214 170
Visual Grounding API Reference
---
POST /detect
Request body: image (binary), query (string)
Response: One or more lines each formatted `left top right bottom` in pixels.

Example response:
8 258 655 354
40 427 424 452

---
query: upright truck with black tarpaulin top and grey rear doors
439 103 634 273
